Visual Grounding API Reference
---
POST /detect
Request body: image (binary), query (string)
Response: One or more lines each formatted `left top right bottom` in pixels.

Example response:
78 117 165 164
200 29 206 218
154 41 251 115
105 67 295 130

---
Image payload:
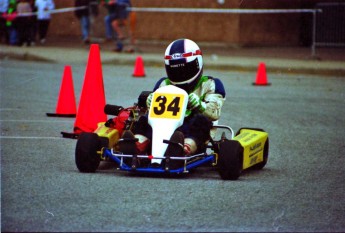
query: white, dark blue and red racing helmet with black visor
164 39 203 91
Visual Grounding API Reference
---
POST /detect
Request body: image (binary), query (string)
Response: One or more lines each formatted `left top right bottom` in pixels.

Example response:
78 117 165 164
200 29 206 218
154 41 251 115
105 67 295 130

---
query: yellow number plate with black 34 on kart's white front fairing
150 93 184 119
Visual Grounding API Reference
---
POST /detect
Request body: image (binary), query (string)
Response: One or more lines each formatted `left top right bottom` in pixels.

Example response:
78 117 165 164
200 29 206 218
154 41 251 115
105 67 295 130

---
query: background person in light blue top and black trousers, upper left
35 0 55 44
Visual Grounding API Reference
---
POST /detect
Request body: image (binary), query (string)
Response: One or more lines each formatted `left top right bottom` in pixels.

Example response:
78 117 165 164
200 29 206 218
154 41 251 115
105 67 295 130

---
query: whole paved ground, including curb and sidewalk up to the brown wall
0 38 345 232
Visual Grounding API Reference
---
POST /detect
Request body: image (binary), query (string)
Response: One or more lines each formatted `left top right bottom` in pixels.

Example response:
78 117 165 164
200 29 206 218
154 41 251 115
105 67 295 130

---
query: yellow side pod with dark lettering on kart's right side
232 129 268 169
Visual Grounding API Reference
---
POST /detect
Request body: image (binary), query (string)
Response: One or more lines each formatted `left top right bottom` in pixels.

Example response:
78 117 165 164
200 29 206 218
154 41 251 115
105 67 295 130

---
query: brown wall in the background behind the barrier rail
49 0 336 46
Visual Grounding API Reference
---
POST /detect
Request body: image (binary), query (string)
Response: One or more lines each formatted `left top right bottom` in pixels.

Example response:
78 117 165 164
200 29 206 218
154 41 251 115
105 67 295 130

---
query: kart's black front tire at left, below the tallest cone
75 133 101 173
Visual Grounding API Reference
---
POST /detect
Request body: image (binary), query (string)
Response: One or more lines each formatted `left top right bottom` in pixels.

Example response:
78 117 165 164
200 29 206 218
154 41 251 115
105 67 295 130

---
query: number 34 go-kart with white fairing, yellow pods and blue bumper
75 85 269 180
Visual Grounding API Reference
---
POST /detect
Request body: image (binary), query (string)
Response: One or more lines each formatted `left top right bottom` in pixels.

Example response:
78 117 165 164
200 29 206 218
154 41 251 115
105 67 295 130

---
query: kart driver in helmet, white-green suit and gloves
123 39 225 156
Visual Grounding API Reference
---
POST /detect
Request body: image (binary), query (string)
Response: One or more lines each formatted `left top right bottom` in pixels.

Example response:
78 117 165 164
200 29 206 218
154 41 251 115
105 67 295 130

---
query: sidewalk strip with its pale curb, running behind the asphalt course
0 36 345 76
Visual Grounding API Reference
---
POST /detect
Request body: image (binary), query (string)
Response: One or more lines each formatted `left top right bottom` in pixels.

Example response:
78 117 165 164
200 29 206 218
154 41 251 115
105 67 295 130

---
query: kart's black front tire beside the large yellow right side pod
218 140 243 180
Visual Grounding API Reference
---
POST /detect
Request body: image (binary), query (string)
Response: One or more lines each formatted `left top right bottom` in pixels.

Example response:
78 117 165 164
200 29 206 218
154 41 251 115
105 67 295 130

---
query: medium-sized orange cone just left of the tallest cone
46 66 77 117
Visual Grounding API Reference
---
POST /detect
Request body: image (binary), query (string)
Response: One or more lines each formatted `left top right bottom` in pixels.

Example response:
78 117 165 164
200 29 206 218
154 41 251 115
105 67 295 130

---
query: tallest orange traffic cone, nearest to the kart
61 44 107 138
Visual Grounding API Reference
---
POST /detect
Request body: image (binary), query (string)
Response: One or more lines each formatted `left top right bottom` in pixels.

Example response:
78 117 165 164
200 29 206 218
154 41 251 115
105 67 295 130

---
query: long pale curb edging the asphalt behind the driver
0 48 345 77
